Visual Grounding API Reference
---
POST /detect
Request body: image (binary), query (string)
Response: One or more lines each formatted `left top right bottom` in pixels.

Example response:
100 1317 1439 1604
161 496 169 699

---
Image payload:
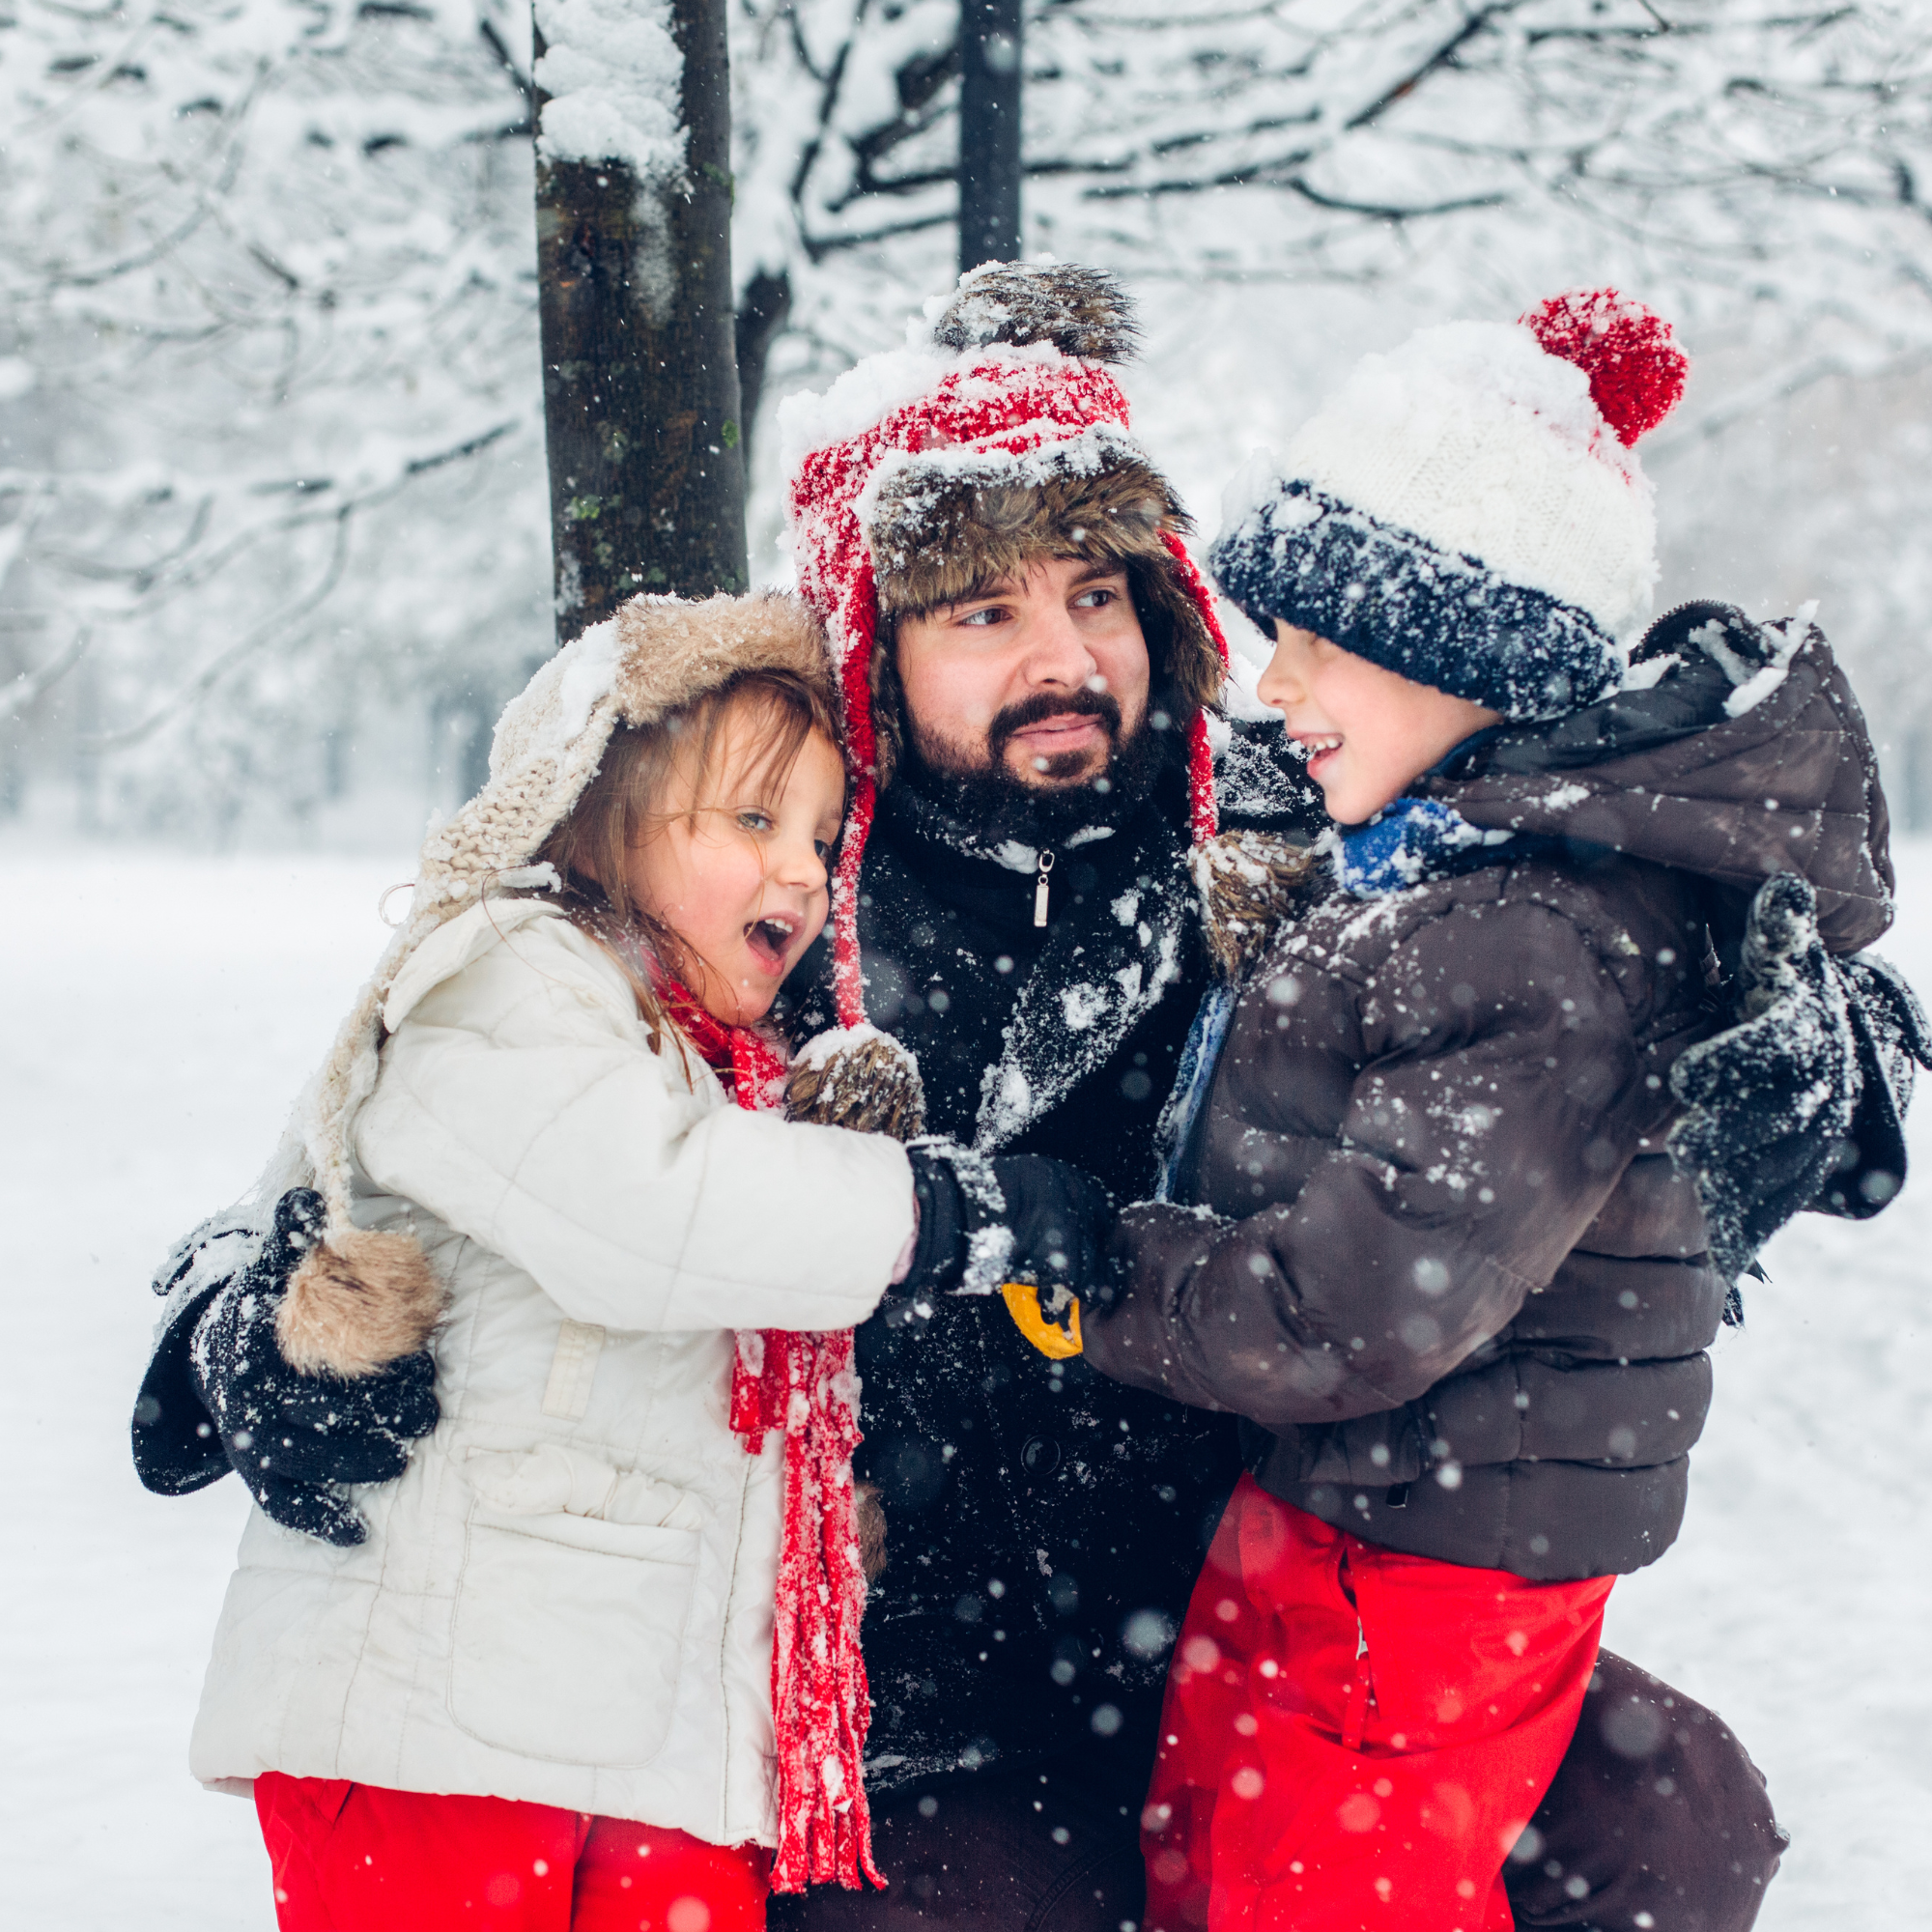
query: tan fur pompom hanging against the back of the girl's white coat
274 1229 446 1381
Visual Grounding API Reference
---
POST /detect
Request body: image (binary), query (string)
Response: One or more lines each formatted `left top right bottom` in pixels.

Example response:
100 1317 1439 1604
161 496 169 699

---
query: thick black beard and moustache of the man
906 692 1169 846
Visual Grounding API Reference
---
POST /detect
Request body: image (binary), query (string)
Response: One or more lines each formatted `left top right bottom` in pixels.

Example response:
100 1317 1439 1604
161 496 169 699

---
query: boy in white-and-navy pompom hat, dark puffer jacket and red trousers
1086 292 1889 1932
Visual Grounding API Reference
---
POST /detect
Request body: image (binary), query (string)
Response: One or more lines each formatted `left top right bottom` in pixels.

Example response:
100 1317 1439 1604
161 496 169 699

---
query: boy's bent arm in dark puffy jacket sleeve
1086 904 1662 1428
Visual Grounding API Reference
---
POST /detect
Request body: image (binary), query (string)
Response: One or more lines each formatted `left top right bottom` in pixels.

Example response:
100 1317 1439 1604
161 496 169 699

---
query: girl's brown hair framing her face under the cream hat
535 670 840 1049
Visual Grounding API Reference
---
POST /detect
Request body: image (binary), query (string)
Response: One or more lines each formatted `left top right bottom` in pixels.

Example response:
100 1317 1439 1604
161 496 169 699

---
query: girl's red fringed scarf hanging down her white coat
657 980 885 1891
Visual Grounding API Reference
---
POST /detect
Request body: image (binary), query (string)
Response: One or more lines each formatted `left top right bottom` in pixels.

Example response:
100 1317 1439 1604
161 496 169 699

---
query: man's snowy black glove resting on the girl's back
187 1188 439 1548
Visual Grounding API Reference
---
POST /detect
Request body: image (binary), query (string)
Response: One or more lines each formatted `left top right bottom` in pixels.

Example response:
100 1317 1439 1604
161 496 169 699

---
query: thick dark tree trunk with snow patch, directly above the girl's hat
537 0 748 643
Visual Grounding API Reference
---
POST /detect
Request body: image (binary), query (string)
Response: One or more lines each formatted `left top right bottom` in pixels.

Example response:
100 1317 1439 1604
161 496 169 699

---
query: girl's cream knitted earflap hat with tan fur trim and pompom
261 593 833 1374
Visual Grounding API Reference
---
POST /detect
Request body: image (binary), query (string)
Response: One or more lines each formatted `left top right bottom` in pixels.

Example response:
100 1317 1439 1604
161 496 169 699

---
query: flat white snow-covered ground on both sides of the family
0 844 1932 1932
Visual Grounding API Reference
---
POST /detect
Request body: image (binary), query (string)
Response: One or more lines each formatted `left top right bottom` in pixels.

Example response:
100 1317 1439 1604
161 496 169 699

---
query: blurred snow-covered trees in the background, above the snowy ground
0 0 1932 842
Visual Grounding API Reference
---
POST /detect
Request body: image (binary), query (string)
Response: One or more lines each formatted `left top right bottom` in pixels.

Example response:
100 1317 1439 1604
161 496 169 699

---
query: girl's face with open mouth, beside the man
626 705 844 1026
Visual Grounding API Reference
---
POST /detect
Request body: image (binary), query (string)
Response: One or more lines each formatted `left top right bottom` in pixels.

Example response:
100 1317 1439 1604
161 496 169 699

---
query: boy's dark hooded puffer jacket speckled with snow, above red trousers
1086 632 1891 1578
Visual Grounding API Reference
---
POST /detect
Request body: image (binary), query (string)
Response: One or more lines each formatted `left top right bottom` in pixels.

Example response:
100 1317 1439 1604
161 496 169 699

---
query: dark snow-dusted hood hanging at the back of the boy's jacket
1412 603 1893 952
